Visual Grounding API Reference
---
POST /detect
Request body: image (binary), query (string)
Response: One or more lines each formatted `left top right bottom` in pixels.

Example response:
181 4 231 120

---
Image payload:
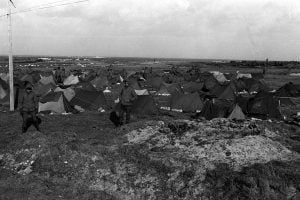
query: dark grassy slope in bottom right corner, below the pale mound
204 161 300 200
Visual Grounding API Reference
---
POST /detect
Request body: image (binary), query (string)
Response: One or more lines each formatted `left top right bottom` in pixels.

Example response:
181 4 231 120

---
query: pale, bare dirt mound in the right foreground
90 119 299 199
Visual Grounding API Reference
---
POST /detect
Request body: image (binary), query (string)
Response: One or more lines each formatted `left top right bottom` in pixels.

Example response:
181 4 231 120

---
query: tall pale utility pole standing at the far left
7 0 15 111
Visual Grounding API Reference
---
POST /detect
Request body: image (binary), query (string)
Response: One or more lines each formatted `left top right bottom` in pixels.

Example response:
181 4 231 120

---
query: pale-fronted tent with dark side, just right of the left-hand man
39 91 73 114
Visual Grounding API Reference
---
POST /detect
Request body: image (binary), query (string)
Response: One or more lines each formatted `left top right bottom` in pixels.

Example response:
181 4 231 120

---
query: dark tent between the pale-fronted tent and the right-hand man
70 89 107 110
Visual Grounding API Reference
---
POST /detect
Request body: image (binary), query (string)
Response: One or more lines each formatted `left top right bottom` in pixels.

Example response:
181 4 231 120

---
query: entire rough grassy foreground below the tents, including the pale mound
0 112 300 200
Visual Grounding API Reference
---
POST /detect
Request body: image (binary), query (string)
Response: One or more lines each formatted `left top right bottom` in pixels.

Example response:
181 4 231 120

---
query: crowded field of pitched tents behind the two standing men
0 69 300 119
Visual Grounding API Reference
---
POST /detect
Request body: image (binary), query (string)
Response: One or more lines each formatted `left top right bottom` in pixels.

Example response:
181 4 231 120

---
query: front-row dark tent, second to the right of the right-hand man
171 93 203 112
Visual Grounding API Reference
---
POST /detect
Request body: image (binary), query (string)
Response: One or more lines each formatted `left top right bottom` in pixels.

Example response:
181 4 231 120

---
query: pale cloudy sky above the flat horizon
0 0 300 60
